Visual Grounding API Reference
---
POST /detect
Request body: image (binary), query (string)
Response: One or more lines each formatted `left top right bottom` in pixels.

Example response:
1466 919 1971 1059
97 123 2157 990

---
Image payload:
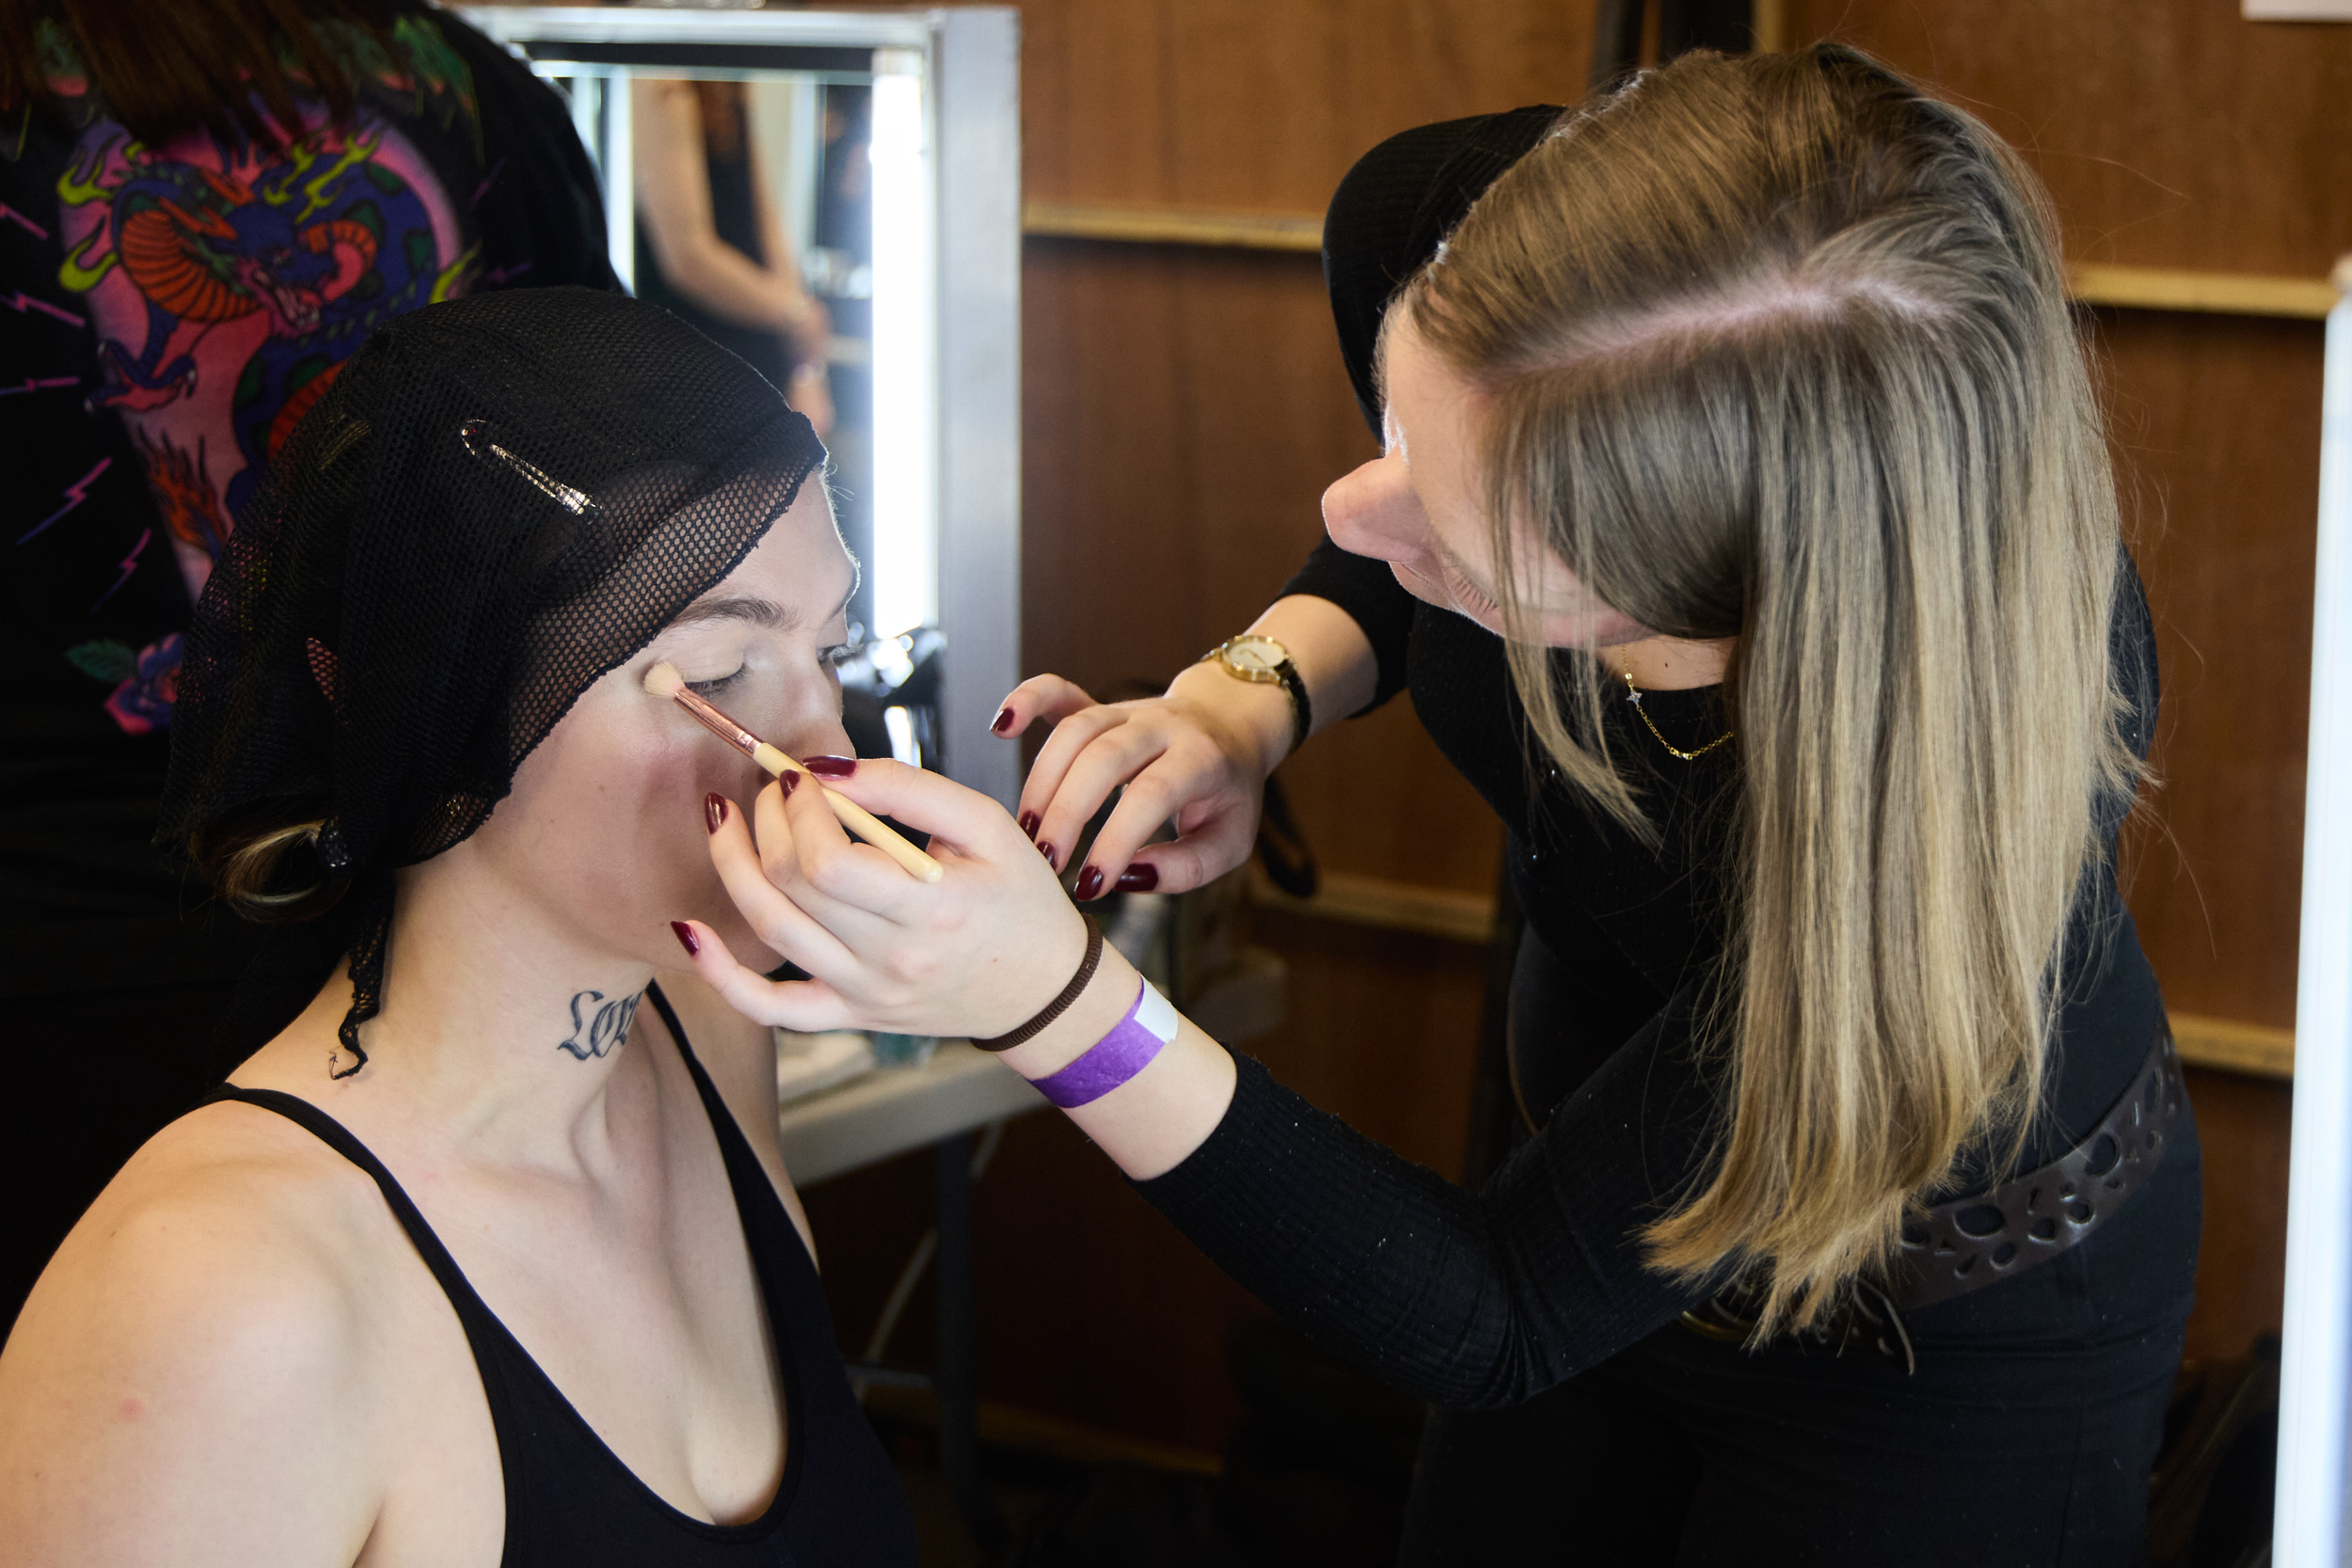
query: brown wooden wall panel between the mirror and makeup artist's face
1021 242 1499 891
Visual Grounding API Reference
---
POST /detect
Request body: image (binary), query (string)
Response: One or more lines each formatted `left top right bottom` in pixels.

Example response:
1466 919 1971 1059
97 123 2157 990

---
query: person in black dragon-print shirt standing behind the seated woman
0 0 619 1328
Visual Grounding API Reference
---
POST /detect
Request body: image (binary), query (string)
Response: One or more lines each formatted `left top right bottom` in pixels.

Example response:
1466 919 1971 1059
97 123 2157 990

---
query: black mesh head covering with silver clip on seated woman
158 289 826 1074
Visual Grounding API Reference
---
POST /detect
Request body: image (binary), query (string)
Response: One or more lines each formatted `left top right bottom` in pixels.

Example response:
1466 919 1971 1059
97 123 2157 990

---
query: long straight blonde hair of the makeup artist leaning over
1400 44 2138 1338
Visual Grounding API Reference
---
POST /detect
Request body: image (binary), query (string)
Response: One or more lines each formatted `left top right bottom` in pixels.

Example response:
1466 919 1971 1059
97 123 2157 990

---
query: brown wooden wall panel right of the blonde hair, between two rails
2101 312 2322 1027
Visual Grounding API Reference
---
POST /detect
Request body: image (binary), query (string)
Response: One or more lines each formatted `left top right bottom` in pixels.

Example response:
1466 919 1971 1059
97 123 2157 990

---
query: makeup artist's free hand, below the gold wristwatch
997 665 1292 898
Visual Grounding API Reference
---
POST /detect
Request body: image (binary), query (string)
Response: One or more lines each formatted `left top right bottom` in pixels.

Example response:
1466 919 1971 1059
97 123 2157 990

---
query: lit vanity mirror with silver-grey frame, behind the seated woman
464 5 1021 806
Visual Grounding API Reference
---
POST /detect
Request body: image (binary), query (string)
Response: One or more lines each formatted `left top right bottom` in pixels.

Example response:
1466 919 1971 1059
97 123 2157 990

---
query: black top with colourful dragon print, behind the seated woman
0 5 616 994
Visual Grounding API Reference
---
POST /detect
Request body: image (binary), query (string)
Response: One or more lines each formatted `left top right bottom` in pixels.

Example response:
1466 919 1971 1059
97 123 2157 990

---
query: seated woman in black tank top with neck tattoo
0 289 915 1568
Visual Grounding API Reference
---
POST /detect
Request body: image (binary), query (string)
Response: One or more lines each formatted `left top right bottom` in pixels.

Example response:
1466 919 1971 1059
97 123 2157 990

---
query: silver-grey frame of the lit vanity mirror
459 5 1021 811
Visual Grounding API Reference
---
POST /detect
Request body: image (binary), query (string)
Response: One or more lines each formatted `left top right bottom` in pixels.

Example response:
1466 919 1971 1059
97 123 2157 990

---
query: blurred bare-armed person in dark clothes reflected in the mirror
630 77 833 435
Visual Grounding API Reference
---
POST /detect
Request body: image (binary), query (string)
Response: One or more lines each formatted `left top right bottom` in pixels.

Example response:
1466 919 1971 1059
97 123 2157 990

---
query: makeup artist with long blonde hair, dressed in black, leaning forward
680 47 2200 1568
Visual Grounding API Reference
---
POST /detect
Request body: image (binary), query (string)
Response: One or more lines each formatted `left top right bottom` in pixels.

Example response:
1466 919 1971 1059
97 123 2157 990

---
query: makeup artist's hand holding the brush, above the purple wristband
682 757 1087 1039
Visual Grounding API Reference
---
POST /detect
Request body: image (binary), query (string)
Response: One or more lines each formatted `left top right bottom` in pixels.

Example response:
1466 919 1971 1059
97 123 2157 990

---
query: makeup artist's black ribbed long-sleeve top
1138 110 2195 1408
